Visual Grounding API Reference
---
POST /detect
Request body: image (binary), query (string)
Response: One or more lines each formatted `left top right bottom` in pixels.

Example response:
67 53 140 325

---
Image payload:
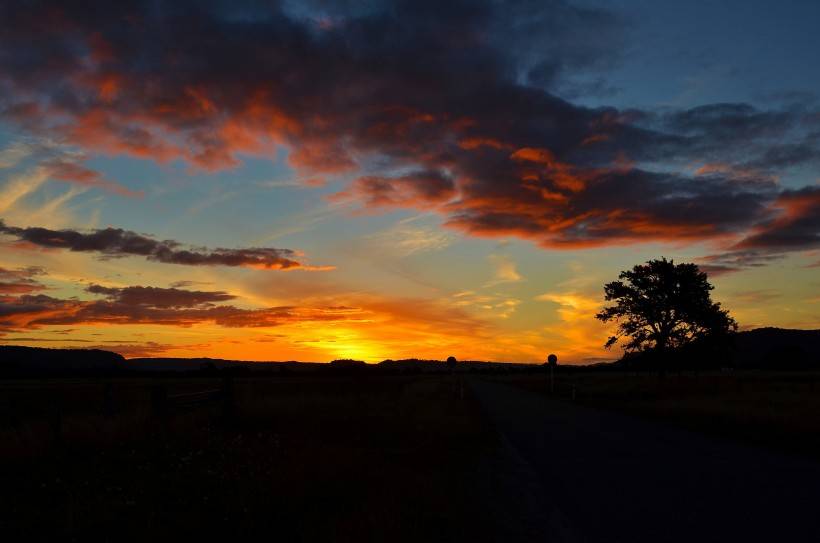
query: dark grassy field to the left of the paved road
0 375 497 541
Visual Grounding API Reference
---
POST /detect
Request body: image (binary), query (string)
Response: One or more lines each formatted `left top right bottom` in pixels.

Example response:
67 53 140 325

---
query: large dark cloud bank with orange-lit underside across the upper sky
0 0 820 268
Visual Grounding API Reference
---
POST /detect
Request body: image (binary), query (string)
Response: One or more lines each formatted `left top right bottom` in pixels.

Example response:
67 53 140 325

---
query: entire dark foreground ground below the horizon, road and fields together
0 374 820 542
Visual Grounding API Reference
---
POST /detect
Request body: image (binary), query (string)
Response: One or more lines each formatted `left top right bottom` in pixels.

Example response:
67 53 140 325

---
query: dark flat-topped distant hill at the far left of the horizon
0 345 125 377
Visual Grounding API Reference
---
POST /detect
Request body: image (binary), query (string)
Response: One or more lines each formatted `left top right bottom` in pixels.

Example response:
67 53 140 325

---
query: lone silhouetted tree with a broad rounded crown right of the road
595 258 737 363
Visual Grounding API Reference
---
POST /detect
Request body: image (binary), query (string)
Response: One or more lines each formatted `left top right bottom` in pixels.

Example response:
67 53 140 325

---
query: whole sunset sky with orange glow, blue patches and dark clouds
0 0 820 363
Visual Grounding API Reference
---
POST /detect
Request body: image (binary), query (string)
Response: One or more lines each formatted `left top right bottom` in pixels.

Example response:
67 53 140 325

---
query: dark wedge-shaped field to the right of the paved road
494 368 820 457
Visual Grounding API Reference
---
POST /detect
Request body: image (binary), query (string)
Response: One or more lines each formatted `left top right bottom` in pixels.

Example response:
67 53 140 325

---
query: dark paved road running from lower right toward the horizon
471 380 820 543
